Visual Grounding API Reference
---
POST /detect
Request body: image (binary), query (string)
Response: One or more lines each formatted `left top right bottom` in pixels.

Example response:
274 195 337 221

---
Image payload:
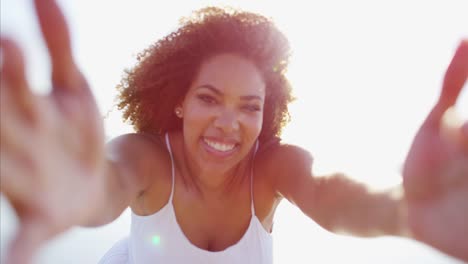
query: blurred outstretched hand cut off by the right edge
403 40 468 261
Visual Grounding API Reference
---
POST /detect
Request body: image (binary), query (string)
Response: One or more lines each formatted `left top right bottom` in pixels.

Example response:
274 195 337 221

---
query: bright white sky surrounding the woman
0 0 468 263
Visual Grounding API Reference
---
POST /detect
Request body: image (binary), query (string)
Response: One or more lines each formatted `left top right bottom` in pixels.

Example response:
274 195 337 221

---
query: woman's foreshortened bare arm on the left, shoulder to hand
82 134 165 226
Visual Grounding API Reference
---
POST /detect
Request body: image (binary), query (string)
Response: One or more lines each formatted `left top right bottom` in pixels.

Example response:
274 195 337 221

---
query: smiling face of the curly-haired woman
182 54 265 177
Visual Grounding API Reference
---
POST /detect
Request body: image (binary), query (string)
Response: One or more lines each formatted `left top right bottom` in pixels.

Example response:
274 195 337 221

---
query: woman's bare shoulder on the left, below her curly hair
107 133 170 202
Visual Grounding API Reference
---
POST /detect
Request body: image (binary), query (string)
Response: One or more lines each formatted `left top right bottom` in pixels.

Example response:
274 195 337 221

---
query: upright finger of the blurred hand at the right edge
428 40 468 126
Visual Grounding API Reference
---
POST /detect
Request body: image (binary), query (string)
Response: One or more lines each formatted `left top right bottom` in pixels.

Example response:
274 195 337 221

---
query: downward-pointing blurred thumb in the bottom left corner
6 220 48 264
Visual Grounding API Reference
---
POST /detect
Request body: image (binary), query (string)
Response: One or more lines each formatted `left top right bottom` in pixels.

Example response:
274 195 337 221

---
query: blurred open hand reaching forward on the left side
0 0 105 264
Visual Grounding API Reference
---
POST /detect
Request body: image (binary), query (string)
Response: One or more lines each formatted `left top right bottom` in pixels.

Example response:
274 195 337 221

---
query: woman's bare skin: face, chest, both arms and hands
0 0 468 263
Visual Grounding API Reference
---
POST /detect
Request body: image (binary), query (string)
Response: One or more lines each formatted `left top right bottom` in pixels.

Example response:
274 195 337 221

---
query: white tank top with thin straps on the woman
99 134 273 264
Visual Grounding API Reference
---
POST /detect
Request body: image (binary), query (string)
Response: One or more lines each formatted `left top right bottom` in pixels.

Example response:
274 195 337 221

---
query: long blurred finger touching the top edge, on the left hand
34 0 83 91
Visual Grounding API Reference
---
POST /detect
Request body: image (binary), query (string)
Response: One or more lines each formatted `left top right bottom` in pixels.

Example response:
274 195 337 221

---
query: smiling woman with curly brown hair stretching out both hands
1 0 468 263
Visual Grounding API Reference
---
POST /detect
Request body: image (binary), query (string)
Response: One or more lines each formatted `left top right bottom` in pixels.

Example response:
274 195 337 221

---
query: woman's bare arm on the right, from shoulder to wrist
270 145 408 236
